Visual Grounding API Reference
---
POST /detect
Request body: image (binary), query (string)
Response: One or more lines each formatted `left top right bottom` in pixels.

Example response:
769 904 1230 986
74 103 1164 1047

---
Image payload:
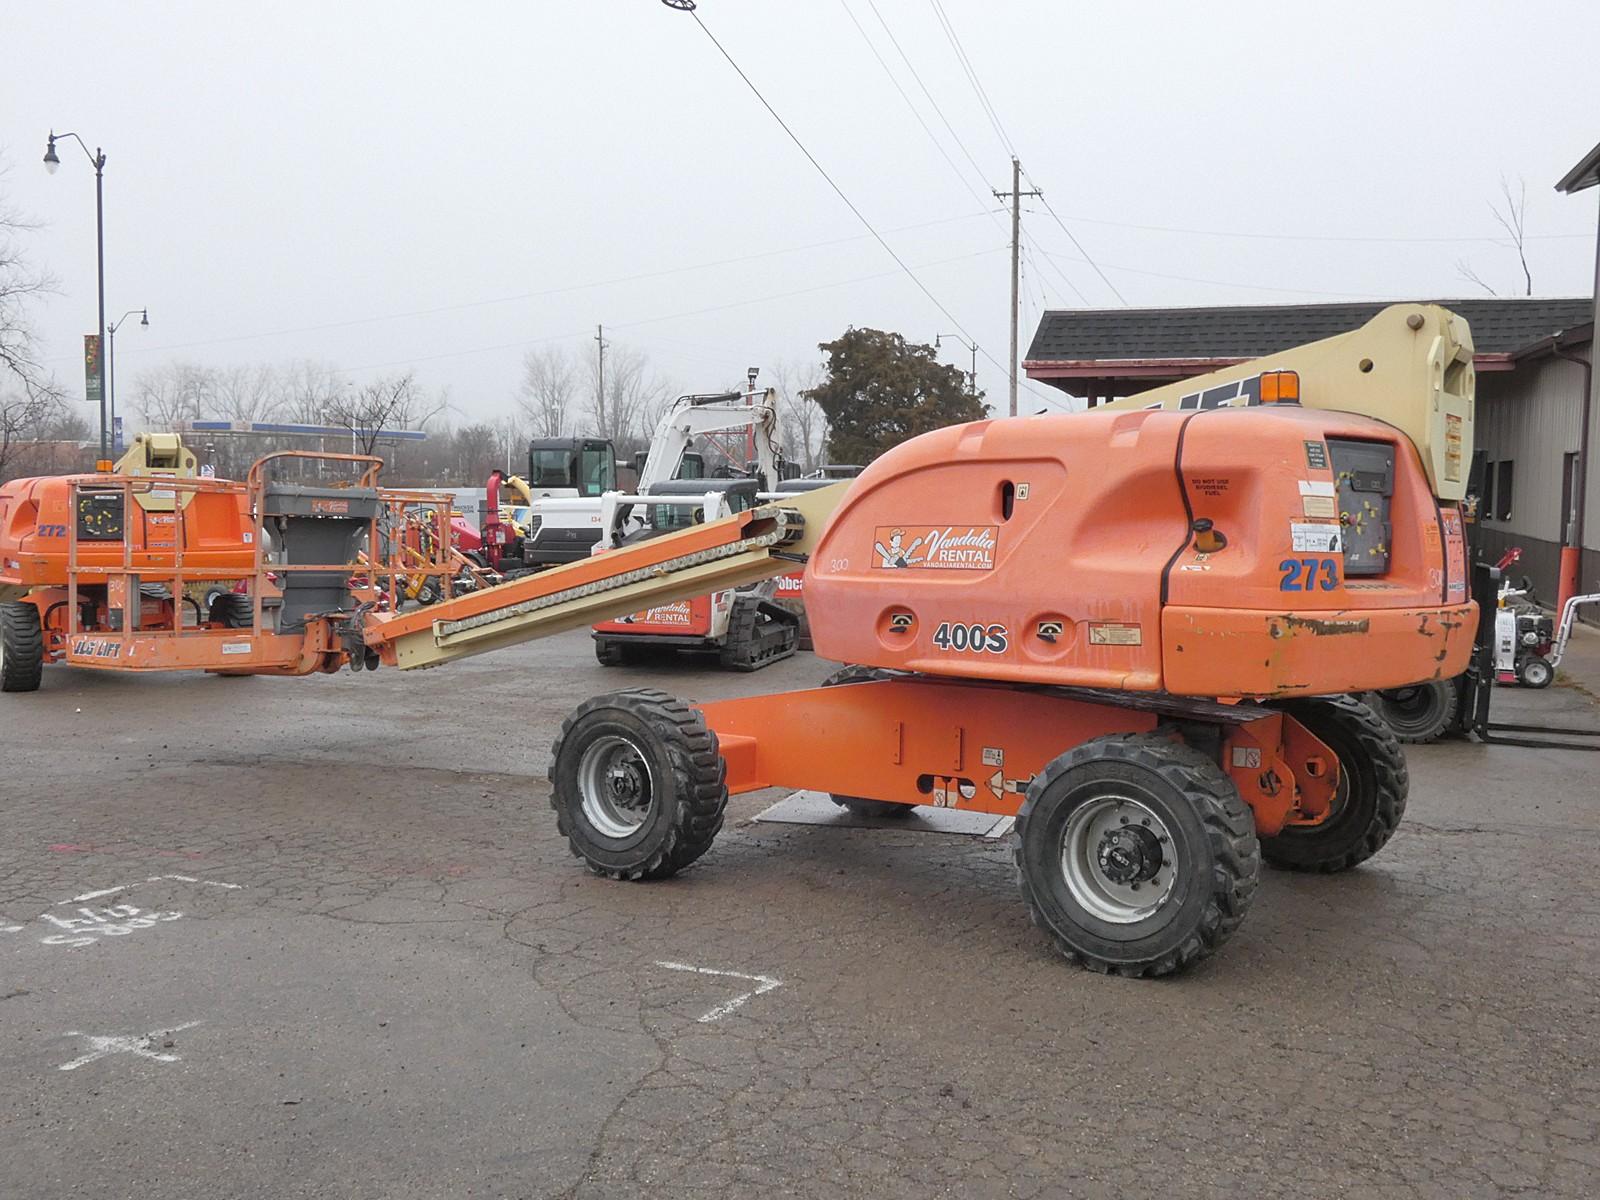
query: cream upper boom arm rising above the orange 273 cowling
1104 304 1477 501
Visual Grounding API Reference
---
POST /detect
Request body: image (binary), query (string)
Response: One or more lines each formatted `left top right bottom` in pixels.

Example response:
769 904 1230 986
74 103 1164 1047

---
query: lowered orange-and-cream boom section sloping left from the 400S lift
365 483 848 670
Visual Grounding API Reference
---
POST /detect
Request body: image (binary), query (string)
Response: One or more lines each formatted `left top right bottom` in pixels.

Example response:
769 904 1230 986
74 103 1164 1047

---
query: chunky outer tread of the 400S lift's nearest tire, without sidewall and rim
1013 733 1261 979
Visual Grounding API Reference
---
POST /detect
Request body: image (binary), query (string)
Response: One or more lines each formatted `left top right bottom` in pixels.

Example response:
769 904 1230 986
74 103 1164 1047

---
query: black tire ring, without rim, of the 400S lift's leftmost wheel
549 688 728 880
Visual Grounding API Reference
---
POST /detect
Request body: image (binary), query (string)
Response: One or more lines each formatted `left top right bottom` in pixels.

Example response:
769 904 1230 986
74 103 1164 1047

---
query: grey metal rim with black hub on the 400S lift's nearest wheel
1061 795 1179 925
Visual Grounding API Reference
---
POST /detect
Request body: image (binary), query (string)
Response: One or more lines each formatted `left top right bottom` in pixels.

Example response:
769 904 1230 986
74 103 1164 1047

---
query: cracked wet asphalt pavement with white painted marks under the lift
0 634 1600 1200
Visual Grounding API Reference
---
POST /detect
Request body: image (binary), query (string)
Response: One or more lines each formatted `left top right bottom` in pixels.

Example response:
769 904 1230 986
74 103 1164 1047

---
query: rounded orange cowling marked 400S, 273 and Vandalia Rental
805 403 1477 696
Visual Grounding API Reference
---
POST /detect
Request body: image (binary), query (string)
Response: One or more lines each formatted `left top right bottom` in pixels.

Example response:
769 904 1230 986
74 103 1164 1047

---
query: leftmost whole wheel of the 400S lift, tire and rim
550 688 728 880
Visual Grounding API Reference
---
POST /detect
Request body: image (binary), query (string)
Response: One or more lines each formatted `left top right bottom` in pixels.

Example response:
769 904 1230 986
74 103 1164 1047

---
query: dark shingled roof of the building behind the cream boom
1027 296 1594 363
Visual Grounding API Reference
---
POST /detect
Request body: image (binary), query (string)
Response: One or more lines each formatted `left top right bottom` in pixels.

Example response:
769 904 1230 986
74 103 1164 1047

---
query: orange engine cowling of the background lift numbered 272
0 475 254 589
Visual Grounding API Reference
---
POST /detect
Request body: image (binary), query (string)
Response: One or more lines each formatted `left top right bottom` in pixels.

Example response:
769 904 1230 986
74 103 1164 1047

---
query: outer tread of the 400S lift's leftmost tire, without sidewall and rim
547 688 728 880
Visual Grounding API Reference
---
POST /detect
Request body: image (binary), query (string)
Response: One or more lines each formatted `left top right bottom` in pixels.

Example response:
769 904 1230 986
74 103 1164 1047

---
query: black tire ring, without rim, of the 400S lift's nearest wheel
1016 733 1261 978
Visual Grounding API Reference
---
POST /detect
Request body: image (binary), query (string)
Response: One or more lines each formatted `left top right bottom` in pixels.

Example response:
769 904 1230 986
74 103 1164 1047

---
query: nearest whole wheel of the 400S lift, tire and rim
1016 734 1261 976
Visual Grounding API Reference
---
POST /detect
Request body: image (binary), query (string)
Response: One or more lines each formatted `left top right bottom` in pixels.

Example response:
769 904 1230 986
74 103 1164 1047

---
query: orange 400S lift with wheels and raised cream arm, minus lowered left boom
550 306 1477 976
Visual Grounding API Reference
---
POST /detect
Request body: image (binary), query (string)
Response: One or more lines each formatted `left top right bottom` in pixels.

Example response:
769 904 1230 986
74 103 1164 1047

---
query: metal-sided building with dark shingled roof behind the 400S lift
1022 296 1600 603
